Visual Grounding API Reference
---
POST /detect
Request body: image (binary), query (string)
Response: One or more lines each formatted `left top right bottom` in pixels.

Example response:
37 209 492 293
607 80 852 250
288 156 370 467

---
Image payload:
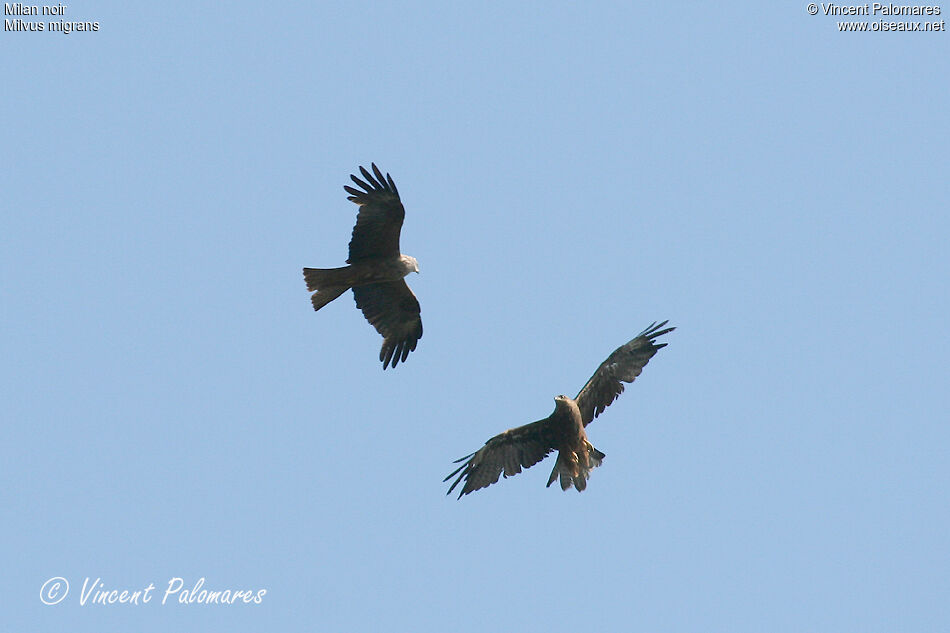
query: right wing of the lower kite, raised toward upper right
575 321 676 426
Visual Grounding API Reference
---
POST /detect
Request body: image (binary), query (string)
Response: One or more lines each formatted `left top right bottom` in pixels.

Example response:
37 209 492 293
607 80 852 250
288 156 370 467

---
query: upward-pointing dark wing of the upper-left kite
343 163 406 264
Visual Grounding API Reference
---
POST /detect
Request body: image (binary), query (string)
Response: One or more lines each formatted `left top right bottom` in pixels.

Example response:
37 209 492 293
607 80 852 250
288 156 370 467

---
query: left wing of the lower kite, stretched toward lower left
443 418 554 499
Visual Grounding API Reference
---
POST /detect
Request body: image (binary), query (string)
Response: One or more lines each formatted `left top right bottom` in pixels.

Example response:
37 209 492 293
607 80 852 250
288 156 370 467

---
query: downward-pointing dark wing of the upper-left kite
353 279 422 369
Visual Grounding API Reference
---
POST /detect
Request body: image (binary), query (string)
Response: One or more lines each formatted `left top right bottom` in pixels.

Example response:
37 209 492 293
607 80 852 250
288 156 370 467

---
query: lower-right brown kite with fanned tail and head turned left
443 321 676 499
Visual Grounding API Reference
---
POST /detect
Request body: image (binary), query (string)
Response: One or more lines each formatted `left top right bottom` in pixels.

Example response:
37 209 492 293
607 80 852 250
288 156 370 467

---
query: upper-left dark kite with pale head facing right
303 164 422 369
